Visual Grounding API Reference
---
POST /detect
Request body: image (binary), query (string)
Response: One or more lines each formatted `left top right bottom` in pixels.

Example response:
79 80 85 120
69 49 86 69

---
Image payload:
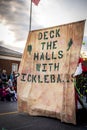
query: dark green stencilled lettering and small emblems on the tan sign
21 28 73 83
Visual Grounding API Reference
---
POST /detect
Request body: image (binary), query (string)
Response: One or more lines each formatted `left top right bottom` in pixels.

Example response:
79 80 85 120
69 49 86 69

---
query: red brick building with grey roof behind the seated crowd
0 46 22 75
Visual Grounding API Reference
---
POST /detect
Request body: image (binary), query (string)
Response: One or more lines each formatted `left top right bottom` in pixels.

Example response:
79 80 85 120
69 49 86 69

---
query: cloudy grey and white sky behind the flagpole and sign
0 0 87 53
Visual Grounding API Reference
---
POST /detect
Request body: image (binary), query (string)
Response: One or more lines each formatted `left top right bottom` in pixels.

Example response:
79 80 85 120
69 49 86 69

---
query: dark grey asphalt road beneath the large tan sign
0 101 87 130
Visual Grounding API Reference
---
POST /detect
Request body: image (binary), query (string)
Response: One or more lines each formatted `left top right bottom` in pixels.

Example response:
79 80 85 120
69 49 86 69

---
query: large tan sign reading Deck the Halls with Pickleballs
18 21 85 124
